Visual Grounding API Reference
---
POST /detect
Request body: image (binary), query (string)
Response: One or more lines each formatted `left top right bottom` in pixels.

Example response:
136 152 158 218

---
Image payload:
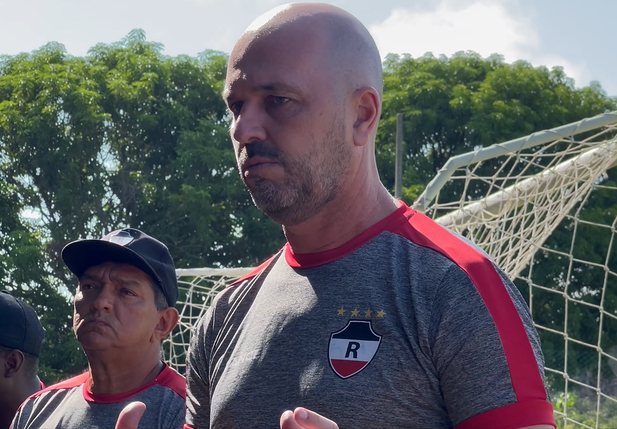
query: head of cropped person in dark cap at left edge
0 291 45 429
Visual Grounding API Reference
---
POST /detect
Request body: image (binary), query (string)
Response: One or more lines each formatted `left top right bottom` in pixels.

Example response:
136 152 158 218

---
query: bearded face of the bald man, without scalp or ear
224 30 351 226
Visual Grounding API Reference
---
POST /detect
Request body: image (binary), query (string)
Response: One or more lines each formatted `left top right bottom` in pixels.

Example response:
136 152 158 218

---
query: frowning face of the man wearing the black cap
73 262 159 351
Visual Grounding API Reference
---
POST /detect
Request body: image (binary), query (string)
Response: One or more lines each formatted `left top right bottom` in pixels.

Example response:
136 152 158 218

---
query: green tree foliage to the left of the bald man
0 30 283 382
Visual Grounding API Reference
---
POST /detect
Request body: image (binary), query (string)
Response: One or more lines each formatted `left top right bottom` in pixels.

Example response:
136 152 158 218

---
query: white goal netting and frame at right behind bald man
414 112 617 429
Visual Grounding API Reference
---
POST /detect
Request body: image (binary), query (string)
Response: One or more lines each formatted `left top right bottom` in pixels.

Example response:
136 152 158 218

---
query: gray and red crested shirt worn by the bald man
186 205 554 429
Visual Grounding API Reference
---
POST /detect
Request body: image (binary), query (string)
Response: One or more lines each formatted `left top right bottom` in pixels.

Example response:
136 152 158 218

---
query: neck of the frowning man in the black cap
86 353 165 395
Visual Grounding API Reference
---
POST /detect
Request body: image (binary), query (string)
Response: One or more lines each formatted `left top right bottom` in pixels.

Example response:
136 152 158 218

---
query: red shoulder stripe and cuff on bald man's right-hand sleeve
391 209 555 429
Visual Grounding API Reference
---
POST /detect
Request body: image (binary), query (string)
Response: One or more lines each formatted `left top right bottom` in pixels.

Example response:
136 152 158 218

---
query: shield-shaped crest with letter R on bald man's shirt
328 320 381 378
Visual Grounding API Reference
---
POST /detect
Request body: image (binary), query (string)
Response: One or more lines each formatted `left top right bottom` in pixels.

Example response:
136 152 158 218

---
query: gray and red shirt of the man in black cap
11 366 186 429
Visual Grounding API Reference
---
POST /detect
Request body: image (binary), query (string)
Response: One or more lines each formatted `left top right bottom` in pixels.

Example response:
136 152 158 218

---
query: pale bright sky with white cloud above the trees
0 0 617 96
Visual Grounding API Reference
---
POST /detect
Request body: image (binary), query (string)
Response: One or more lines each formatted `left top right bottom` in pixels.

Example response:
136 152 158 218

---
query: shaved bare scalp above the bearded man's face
229 3 383 100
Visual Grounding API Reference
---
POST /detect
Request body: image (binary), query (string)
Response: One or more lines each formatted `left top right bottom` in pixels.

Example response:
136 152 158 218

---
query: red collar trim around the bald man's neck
284 201 416 268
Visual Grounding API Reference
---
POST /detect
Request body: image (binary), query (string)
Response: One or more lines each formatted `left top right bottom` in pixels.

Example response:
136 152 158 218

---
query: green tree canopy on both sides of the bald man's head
0 30 616 382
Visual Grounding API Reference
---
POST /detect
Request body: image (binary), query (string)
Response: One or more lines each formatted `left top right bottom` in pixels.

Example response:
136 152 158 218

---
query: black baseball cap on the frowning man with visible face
62 228 178 307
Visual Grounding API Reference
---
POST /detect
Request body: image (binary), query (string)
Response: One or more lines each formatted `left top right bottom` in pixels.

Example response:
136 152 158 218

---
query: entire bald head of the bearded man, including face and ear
223 3 383 227
